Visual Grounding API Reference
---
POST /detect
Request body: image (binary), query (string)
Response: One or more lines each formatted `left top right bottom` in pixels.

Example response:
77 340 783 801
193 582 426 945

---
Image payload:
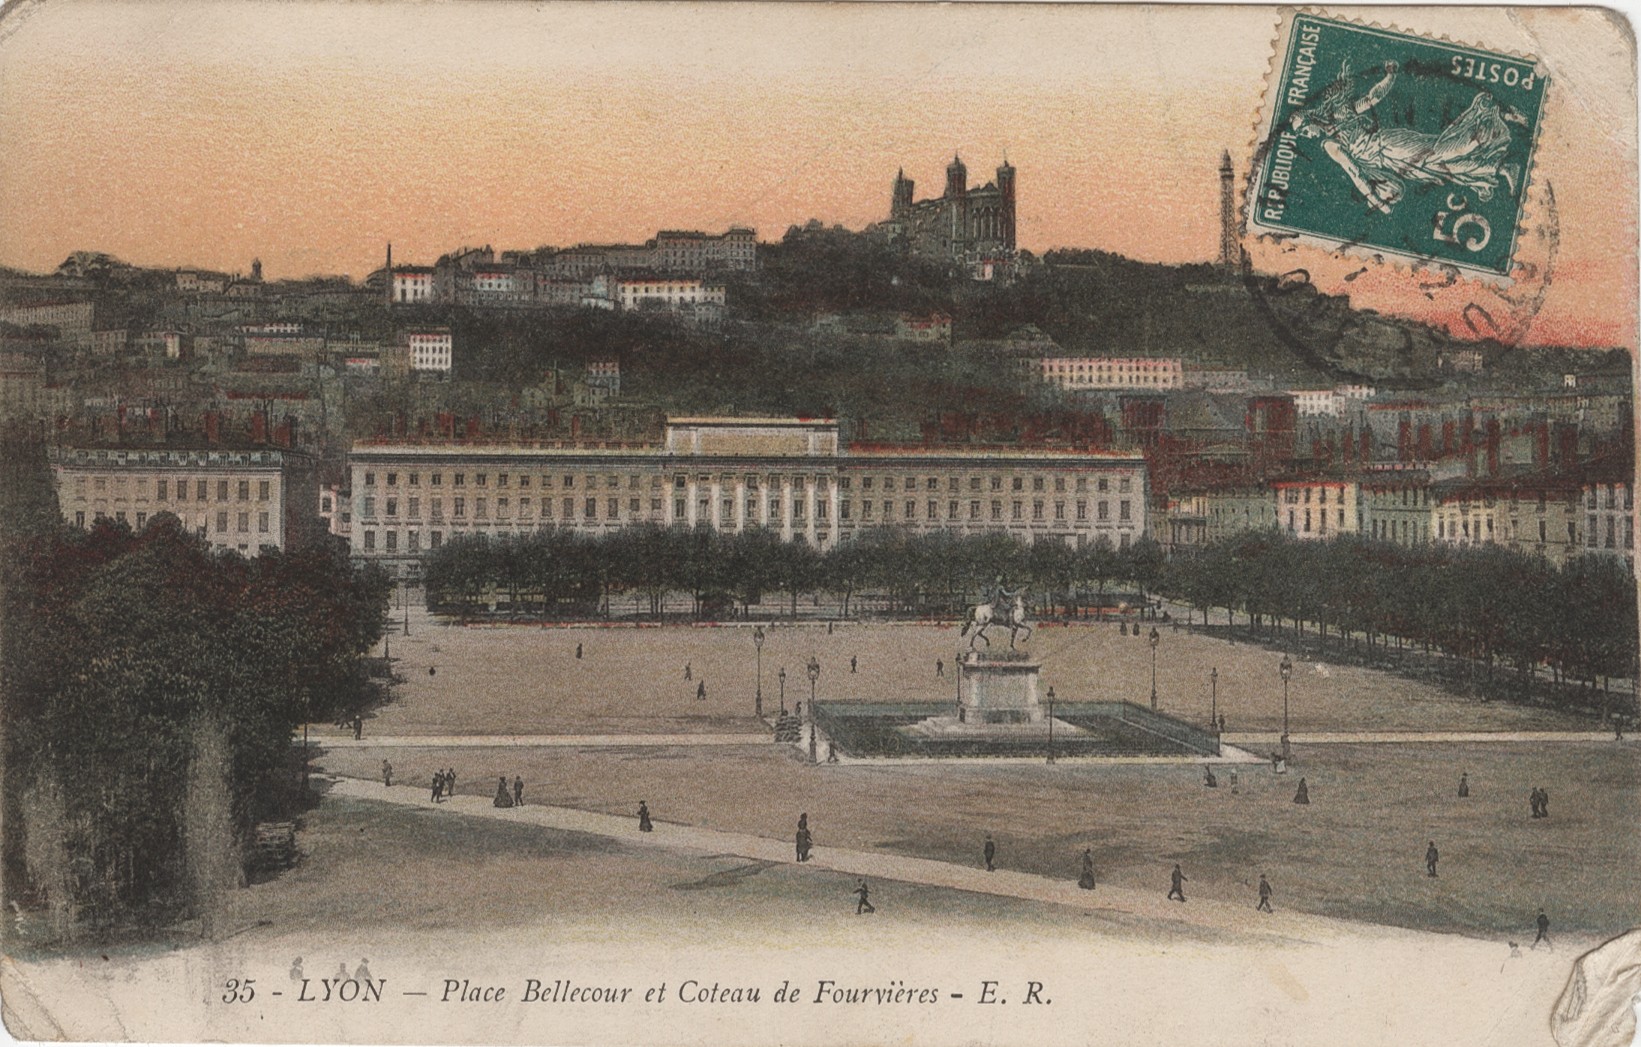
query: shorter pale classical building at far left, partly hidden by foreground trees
51 446 322 556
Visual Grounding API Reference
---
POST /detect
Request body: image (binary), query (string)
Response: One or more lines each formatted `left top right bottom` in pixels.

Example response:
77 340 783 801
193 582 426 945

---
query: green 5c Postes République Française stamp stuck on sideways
1247 13 1549 277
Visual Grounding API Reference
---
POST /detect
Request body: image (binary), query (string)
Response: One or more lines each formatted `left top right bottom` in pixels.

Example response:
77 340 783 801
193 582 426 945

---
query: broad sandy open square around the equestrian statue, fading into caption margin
13 609 1641 1044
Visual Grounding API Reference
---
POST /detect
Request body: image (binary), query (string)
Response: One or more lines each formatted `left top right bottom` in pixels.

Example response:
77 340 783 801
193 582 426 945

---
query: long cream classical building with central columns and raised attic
350 418 1149 584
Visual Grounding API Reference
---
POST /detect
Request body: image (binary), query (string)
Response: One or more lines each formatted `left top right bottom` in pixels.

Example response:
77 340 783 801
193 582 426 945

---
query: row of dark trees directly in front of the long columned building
425 524 1162 615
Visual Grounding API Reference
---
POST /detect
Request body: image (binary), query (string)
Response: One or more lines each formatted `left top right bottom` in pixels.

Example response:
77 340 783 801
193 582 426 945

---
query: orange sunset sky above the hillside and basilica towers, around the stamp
0 0 1636 346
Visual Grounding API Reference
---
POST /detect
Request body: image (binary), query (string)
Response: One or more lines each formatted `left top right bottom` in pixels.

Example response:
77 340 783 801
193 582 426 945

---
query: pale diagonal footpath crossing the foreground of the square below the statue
330 776 1470 949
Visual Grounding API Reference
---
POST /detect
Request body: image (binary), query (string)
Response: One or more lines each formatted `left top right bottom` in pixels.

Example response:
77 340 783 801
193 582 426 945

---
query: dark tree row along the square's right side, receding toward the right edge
1162 532 1636 702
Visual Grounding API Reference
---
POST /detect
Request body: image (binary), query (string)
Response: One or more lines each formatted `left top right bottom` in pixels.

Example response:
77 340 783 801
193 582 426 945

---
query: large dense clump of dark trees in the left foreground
3 514 391 932
